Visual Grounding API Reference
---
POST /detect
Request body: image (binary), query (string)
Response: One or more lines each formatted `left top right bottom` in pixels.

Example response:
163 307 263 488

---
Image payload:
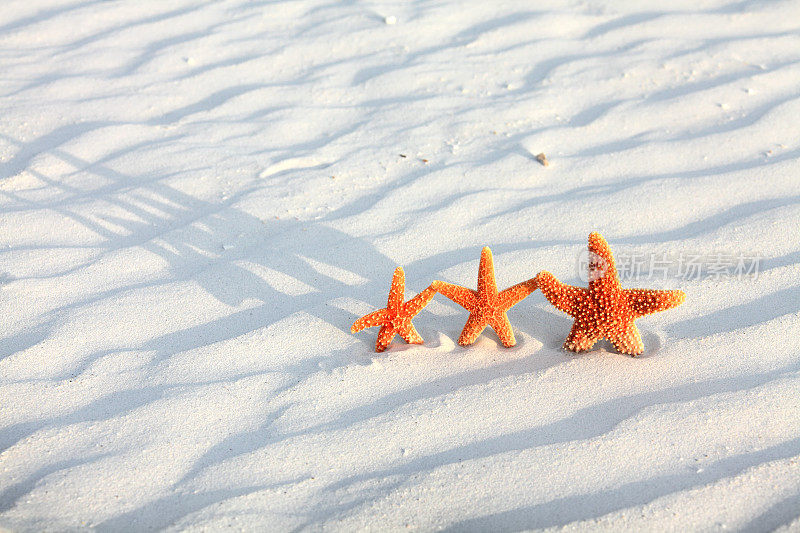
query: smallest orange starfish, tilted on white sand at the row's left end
350 267 436 352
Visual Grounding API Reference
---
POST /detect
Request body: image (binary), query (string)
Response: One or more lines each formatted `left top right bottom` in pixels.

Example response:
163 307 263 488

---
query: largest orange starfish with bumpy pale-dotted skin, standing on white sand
536 233 686 355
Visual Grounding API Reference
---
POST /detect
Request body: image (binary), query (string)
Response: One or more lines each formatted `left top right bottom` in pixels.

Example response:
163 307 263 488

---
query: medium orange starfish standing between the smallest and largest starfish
431 246 536 347
